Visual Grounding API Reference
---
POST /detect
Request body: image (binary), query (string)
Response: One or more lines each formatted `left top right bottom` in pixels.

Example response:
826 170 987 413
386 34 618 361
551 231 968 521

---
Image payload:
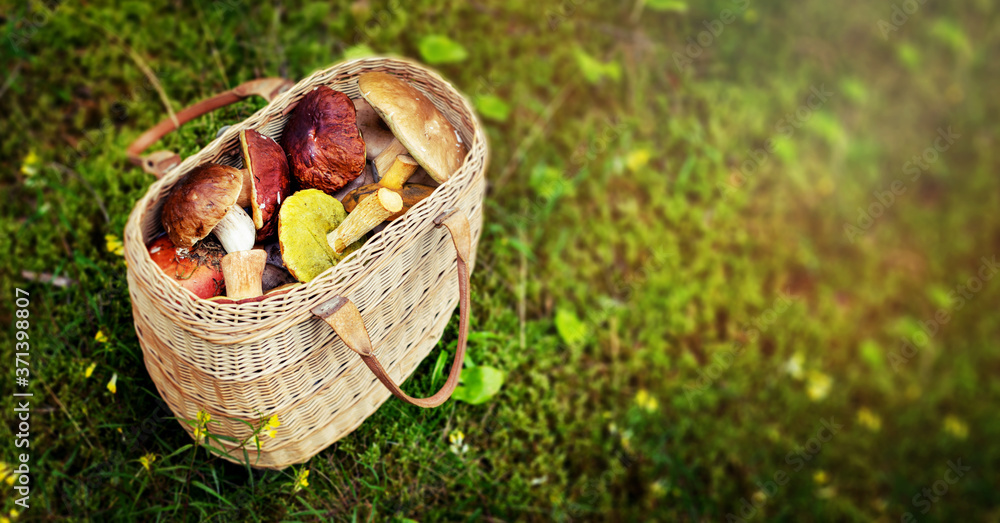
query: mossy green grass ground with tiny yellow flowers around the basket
0 0 1000 521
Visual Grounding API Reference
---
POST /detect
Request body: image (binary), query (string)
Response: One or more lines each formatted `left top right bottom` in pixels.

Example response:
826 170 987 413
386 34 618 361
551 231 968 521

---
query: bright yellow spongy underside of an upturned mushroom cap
278 189 361 283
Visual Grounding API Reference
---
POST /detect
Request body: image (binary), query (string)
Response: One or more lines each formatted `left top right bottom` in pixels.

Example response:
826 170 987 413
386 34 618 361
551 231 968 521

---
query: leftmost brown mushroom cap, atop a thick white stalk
160 163 243 249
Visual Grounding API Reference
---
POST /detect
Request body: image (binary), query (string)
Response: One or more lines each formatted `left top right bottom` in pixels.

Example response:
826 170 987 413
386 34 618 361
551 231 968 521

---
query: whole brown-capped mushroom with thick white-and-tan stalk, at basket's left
160 163 267 297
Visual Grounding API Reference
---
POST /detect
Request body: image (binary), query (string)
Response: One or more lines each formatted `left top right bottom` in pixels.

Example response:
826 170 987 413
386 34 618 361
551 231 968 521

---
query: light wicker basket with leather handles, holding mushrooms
125 57 488 468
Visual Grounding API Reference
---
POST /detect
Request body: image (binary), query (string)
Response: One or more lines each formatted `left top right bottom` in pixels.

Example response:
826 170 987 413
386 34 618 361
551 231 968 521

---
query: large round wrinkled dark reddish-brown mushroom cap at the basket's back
282 85 365 194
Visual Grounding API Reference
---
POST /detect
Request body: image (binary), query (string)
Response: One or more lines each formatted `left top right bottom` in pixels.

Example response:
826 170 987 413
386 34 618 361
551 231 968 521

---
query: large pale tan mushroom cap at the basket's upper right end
358 72 468 183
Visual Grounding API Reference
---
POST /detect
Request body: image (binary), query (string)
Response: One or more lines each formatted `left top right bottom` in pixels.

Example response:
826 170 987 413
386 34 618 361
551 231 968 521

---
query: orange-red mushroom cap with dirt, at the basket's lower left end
149 234 226 299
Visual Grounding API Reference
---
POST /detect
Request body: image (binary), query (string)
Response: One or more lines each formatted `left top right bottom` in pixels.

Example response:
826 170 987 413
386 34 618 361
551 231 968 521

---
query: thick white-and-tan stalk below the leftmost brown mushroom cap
212 205 267 300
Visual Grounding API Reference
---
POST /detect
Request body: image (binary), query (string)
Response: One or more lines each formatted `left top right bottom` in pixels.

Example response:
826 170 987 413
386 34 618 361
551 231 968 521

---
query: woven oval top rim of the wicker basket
124 55 489 345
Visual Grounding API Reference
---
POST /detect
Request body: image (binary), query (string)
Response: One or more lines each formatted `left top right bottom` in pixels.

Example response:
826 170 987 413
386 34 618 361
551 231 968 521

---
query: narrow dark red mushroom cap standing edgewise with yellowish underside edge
240 129 292 242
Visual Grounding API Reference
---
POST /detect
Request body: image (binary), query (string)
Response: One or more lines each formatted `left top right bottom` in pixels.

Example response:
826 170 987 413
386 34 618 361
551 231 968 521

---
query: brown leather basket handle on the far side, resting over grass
127 78 295 178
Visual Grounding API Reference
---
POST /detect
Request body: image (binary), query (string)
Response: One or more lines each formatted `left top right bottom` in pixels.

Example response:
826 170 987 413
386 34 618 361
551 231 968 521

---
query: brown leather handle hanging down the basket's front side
312 209 471 408
